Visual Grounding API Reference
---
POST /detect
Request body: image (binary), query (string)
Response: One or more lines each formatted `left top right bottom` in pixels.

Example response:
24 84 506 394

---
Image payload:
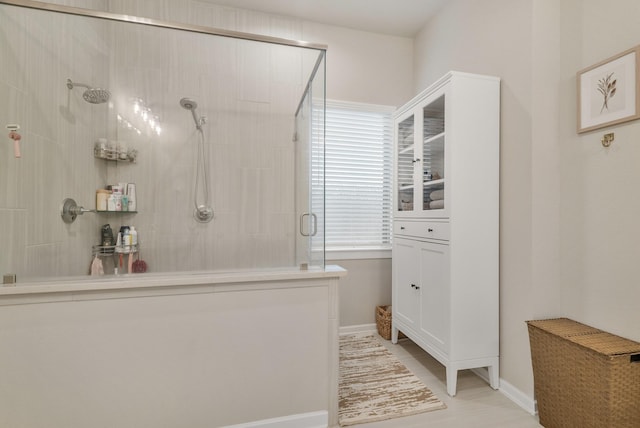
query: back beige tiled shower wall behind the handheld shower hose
108 1 308 272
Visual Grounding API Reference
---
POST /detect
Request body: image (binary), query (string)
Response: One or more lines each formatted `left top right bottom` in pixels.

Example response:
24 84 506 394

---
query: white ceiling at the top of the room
208 0 446 37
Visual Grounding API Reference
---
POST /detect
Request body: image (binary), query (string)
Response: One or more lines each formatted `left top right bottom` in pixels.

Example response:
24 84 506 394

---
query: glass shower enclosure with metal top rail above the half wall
0 0 326 283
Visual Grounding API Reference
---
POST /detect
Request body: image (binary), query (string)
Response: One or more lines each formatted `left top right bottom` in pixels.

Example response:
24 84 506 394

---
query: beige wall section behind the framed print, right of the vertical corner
559 0 640 340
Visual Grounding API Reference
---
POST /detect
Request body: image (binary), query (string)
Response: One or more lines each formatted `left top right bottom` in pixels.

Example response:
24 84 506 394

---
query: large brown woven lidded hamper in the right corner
527 318 640 428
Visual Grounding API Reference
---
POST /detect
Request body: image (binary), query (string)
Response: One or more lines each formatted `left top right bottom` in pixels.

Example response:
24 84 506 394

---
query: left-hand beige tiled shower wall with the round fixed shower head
0 2 108 281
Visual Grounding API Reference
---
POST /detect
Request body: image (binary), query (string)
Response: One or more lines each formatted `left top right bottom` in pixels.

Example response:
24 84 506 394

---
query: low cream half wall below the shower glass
0 271 341 428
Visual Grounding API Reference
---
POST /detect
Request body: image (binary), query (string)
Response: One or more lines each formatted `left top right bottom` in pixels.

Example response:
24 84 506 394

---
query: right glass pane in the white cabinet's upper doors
421 95 446 211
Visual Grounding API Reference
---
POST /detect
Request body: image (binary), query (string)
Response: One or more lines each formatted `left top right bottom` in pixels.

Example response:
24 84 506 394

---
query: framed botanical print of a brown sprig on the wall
577 46 640 133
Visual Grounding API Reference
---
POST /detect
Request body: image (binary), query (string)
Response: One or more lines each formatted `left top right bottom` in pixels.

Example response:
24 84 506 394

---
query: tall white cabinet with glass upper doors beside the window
392 72 500 396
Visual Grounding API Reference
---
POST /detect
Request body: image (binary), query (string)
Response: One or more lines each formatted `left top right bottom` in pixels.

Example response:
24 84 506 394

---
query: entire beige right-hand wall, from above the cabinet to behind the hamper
415 0 640 404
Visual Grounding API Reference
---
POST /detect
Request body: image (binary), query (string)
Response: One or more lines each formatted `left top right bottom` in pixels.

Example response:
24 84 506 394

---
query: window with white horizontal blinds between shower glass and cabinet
325 101 394 251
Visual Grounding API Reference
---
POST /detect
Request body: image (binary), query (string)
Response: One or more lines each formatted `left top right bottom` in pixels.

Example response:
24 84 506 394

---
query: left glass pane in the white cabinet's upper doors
396 115 419 211
